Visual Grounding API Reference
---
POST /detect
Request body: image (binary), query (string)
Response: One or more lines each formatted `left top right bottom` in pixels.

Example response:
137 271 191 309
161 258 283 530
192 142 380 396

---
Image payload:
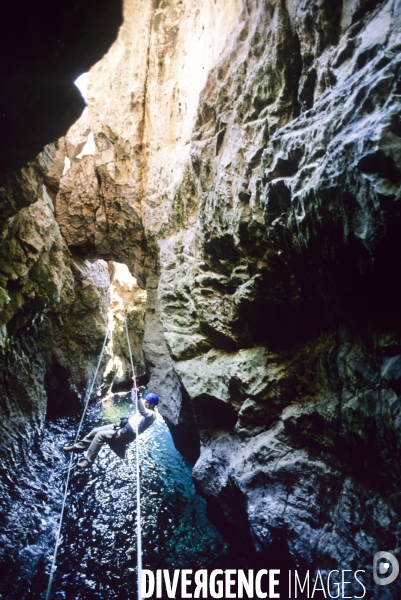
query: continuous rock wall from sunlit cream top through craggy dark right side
50 0 401 597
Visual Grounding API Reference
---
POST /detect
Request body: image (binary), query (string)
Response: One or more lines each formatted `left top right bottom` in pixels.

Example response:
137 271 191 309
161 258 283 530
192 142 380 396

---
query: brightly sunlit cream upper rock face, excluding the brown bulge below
88 0 242 225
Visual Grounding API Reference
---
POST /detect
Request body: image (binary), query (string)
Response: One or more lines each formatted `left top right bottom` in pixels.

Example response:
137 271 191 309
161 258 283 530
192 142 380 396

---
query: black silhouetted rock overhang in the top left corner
0 0 122 179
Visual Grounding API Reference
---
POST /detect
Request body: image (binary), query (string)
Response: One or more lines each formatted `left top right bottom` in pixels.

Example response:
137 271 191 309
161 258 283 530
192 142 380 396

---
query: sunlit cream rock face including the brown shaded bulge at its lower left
55 0 239 286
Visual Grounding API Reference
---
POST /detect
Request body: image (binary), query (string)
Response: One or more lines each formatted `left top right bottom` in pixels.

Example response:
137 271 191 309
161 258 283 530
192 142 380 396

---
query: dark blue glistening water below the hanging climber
36 396 249 600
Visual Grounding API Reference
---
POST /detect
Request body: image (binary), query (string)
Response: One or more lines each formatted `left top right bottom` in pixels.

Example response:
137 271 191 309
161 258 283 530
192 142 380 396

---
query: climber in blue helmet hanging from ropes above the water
63 390 159 468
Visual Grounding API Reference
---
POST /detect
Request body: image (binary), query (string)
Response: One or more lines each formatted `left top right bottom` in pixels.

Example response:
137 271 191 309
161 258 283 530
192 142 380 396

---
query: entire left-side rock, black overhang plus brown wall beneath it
0 0 122 468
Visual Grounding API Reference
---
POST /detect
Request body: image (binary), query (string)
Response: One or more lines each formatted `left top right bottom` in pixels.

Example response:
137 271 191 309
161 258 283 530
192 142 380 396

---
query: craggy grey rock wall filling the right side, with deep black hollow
159 2 401 594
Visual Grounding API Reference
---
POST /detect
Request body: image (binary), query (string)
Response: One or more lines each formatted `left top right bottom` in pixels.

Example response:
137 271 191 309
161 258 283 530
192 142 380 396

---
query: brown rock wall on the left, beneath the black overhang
0 147 110 474
